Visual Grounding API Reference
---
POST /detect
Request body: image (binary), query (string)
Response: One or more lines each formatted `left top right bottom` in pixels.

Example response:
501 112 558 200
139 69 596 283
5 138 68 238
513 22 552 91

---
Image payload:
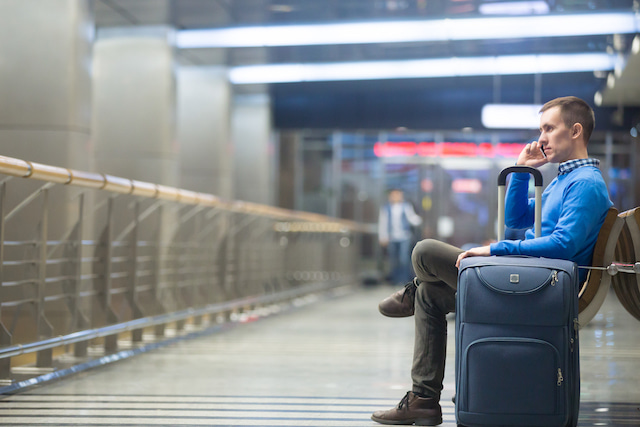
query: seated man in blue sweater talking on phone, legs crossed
371 97 612 426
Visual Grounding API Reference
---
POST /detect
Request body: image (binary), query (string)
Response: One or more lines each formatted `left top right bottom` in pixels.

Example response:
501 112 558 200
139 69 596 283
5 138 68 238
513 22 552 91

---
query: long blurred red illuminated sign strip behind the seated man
373 141 526 158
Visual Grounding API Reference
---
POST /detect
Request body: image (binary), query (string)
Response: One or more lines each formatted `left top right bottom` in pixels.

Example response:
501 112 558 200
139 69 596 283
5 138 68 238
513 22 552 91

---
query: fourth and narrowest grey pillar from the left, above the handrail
232 94 278 205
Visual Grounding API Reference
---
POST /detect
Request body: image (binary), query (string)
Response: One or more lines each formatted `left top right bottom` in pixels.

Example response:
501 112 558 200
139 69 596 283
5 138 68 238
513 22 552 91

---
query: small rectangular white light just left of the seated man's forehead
482 104 542 129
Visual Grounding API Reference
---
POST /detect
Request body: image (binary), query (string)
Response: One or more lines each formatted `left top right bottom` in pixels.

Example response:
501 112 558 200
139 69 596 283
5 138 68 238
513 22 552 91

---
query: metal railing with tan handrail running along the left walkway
0 156 367 384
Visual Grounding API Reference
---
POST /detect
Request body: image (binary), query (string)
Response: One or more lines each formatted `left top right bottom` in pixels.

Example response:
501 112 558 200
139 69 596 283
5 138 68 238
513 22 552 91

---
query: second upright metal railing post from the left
35 189 53 368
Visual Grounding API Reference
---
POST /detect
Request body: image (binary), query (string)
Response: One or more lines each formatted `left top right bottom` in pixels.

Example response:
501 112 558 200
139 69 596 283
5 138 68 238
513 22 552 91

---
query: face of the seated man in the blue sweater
538 107 577 163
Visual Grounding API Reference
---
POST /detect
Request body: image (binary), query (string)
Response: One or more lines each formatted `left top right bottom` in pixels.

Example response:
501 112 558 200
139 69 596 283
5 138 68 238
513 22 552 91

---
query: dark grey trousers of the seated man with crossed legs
411 239 463 399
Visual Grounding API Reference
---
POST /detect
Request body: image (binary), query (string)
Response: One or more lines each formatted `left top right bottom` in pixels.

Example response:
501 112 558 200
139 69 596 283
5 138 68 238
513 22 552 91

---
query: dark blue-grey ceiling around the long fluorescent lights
94 0 640 130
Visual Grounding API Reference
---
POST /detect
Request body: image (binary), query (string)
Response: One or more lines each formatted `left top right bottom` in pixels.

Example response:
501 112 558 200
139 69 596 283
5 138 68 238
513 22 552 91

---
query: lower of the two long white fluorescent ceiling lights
229 53 616 84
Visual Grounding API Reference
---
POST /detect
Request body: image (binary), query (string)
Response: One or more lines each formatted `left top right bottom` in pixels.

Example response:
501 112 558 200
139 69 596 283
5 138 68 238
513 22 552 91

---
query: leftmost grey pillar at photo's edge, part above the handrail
0 0 93 170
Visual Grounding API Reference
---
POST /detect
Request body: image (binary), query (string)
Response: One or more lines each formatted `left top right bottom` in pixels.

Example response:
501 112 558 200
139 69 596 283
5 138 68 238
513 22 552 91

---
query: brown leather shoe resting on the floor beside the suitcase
371 391 442 426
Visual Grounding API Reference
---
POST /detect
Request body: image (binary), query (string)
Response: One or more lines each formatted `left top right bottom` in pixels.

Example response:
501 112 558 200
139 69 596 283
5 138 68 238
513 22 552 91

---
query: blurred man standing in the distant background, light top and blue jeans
378 189 422 285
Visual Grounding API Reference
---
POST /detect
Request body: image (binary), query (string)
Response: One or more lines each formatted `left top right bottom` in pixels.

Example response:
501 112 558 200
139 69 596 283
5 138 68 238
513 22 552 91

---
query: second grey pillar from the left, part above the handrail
93 28 180 186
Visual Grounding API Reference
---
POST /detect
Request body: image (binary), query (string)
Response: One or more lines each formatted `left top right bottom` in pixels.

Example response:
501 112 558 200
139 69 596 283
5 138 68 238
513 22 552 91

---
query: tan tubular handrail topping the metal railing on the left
0 155 369 232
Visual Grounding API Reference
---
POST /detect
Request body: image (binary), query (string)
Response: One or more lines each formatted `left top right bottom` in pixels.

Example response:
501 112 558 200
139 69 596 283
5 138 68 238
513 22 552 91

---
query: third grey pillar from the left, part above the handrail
177 67 233 199
